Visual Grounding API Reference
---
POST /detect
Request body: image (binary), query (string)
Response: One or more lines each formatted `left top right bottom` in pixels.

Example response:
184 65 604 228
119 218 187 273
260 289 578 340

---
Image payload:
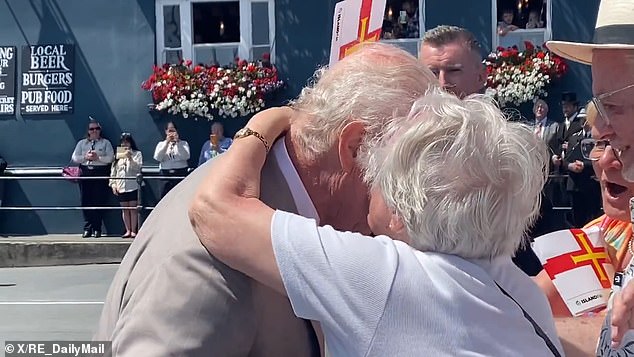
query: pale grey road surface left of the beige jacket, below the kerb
0 264 118 345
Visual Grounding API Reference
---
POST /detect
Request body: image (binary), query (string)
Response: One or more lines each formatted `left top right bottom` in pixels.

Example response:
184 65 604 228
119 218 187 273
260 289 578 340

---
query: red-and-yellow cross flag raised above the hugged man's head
330 0 387 66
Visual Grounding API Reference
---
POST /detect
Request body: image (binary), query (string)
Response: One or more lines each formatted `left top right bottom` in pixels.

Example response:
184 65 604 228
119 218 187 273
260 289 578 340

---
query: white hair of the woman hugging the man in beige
367 89 548 259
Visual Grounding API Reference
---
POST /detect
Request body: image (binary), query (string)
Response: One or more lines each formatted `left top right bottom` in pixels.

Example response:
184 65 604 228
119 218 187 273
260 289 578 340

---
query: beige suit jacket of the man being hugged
94 155 319 357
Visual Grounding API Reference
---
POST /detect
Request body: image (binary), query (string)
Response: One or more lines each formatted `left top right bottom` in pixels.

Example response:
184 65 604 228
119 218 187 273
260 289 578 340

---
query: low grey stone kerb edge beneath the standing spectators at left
0 240 132 268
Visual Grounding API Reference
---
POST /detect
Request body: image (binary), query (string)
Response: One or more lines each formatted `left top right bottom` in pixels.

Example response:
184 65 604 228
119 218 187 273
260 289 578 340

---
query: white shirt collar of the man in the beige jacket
273 138 319 223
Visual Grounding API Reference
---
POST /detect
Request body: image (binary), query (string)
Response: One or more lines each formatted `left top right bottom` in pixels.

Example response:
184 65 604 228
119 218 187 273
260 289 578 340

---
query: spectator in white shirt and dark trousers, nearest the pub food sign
71 118 114 238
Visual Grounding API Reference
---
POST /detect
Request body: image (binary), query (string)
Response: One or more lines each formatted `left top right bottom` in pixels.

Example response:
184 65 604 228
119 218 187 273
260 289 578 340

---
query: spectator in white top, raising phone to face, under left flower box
154 121 189 198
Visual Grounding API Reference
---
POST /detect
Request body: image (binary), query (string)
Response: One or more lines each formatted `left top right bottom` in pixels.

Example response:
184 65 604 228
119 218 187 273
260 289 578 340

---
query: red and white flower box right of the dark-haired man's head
484 42 568 108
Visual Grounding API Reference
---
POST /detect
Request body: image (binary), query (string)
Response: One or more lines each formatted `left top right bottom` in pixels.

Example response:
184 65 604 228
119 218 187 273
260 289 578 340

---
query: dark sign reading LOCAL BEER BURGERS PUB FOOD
20 44 75 115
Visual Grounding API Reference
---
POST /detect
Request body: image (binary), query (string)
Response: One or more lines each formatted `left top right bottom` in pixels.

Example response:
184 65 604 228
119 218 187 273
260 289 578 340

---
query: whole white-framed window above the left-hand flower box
155 0 275 66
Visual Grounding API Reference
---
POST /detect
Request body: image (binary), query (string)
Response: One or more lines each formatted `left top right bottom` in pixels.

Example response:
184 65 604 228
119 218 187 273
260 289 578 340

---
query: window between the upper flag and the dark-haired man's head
381 0 425 56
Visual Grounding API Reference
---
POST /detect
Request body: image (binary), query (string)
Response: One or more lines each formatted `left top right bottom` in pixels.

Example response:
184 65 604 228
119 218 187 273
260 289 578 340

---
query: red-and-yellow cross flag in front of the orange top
533 227 614 316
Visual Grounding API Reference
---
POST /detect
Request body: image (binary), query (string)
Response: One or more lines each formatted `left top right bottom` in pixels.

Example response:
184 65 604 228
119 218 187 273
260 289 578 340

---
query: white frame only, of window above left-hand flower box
155 0 275 65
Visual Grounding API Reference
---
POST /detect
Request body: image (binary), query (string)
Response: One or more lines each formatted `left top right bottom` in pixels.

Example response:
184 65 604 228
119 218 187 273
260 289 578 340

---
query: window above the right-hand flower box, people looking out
492 0 552 50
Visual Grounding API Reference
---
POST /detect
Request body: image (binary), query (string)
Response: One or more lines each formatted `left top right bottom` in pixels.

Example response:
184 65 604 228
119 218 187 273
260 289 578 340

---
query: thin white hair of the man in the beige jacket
291 43 437 159
